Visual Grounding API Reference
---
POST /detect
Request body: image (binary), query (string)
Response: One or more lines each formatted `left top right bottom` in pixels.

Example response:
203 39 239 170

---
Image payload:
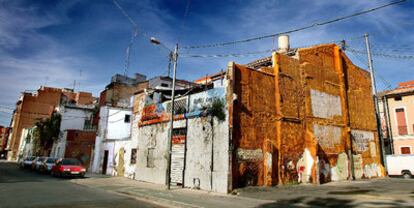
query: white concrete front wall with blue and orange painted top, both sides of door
137 83 230 193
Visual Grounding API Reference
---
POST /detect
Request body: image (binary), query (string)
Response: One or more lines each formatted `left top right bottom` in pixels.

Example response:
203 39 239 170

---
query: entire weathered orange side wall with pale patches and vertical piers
233 44 382 187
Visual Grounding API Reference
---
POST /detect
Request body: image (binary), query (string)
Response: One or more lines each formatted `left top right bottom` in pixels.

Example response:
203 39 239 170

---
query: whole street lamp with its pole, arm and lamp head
150 37 178 189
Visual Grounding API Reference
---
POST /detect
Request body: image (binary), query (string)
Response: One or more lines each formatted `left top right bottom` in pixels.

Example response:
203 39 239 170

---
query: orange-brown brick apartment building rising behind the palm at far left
8 86 95 161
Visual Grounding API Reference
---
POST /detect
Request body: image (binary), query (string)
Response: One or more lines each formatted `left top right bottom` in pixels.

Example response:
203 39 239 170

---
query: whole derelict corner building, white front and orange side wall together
132 44 384 193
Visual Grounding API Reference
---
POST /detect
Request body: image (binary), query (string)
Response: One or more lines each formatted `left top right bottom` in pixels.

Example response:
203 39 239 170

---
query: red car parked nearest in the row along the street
51 158 86 178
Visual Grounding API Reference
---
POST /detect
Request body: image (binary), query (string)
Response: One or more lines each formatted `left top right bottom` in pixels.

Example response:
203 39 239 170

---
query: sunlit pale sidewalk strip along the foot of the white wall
72 177 274 208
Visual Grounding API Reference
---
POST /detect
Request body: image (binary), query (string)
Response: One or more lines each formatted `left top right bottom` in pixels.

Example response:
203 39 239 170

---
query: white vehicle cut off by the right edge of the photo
387 155 414 179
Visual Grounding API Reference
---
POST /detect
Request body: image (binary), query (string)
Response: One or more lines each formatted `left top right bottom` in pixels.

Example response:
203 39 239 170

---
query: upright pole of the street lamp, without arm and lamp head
166 43 178 189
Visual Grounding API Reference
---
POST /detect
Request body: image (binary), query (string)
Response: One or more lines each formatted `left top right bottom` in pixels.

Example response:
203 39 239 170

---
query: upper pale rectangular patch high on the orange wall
310 89 342 118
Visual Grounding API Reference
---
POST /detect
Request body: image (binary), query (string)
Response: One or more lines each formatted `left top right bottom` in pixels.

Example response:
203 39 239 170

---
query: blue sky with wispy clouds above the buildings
0 0 414 125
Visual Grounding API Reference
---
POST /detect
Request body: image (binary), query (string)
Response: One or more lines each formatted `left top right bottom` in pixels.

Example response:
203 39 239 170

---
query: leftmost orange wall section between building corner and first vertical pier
232 65 276 187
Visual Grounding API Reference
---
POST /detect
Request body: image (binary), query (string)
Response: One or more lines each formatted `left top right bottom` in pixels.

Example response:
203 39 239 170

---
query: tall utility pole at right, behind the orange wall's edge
364 33 387 170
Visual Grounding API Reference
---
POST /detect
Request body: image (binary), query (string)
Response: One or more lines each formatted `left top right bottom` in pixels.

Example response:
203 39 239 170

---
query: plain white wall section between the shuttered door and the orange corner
184 116 230 193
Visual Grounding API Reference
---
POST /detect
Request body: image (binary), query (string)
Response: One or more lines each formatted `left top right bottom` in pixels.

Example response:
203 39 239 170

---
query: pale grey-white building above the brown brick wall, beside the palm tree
50 104 95 158
